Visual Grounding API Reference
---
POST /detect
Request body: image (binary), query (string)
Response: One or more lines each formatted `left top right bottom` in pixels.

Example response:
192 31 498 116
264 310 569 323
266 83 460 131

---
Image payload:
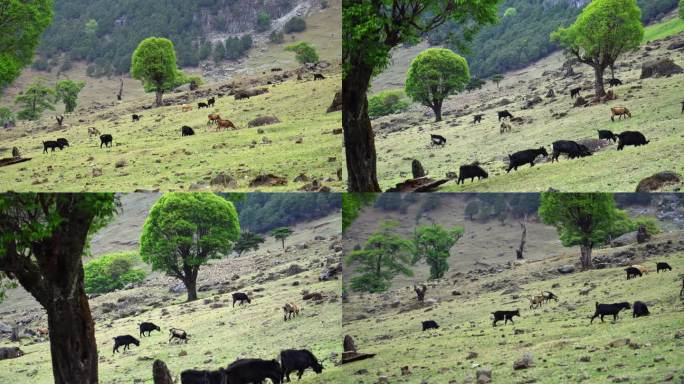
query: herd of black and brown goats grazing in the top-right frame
430 79 684 184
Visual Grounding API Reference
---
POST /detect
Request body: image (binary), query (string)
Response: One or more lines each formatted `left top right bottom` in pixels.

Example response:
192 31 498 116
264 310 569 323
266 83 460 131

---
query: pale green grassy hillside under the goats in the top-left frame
0 74 342 192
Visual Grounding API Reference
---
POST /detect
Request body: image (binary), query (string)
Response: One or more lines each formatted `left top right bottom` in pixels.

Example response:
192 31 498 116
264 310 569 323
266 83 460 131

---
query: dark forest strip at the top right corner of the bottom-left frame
235 193 342 233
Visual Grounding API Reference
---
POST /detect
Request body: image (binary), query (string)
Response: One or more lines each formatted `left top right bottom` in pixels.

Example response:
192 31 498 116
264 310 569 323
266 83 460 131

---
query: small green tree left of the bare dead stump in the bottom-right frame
413 224 463 279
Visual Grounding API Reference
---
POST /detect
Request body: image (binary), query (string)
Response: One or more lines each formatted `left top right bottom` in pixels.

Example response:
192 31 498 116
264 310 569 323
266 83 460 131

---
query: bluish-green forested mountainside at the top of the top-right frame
427 0 677 78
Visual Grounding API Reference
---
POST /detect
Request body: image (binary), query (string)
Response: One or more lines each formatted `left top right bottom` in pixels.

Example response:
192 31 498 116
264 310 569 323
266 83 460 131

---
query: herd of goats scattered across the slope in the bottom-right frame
422 262 684 331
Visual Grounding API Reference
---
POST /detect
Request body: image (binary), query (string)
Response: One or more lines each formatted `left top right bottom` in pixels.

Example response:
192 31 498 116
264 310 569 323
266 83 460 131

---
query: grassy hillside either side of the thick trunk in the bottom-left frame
0 215 342 384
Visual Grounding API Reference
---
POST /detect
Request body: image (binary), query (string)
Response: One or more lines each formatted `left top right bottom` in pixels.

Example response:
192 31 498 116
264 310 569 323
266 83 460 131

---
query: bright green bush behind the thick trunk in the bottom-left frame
83 252 147 293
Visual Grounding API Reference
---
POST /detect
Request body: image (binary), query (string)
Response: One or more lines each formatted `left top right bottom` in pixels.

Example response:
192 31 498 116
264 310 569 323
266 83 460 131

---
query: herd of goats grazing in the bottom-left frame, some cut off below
104 292 323 384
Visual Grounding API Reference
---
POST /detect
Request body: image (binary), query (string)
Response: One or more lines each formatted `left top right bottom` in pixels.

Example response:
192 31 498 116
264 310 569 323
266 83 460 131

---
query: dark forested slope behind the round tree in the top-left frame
34 0 298 76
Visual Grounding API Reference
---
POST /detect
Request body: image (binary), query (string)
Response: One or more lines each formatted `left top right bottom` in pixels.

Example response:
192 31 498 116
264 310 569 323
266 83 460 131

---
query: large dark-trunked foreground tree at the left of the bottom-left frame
0 193 116 384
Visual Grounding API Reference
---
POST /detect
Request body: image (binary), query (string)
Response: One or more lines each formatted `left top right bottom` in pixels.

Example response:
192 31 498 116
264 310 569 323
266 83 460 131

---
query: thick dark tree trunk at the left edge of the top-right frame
342 61 381 192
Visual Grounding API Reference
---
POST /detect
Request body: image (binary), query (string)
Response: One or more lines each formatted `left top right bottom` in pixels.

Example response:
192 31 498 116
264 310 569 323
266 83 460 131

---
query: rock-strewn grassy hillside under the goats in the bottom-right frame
340 233 684 383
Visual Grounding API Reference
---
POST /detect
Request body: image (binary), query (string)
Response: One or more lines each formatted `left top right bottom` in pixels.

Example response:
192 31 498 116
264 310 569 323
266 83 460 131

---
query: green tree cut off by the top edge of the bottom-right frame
539 192 620 270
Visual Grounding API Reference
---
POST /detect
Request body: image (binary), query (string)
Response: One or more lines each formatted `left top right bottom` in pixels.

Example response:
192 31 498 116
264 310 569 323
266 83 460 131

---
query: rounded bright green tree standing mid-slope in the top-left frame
131 37 183 106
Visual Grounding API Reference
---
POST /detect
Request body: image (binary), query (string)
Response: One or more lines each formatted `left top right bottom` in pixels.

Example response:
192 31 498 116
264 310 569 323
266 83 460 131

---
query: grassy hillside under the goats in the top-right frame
373 33 684 192
